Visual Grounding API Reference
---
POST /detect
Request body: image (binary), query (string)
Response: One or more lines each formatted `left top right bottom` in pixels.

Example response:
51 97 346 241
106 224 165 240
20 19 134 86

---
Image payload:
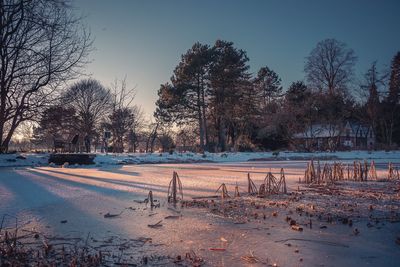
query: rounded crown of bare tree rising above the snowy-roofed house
304 39 357 94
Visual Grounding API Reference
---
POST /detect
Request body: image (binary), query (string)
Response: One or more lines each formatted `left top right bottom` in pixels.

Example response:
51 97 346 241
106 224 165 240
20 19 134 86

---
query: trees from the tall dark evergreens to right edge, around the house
154 39 400 151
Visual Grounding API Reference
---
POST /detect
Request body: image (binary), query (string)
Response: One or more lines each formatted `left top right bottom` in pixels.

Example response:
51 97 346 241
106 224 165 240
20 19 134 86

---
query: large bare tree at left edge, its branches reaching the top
0 0 91 153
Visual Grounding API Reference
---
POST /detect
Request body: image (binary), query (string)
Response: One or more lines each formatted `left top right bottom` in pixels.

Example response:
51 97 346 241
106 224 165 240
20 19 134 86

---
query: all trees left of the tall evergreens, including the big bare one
0 0 172 153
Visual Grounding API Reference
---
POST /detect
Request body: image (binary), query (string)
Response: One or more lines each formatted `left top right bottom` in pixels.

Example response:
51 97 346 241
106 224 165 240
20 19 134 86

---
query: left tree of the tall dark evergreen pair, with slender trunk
156 43 211 150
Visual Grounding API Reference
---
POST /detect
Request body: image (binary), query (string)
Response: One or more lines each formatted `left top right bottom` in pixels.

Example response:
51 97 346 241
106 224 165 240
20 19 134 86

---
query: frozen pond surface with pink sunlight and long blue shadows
0 161 400 266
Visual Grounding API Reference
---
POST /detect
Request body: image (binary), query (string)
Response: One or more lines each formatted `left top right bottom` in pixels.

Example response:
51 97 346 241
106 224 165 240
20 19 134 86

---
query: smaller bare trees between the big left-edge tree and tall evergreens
32 79 159 153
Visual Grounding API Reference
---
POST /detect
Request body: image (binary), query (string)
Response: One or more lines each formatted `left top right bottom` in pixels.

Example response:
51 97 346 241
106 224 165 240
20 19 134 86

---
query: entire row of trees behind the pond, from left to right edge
0 0 400 153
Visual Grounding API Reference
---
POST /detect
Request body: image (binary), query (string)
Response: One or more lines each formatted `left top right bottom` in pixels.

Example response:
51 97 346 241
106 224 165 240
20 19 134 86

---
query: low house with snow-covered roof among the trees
293 121 375 151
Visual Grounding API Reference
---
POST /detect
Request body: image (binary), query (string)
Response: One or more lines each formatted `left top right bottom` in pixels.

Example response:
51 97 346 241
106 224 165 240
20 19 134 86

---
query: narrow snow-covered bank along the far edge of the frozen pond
0 151 400 167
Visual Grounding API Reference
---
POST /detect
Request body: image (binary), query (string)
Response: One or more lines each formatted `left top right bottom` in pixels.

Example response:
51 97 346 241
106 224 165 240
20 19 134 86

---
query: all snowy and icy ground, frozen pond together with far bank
0 156 400 266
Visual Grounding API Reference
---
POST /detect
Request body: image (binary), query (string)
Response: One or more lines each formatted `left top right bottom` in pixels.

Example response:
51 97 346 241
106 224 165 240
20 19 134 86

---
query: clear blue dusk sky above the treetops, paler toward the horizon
74 0 400 115
